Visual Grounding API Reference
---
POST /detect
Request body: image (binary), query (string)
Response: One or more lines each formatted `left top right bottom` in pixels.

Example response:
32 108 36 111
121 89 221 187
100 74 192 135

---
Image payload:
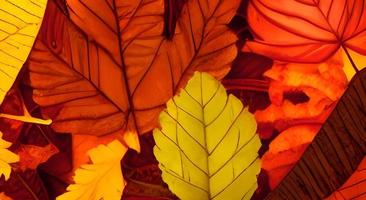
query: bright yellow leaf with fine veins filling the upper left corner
0 0 47 104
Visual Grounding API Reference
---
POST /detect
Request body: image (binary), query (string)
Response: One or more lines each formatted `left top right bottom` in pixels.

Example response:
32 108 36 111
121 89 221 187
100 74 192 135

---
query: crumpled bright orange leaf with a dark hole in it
255 54 347 130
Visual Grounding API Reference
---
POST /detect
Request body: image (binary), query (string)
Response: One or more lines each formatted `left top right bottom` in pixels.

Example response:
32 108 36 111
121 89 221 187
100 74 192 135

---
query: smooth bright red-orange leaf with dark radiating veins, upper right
245 0 366 63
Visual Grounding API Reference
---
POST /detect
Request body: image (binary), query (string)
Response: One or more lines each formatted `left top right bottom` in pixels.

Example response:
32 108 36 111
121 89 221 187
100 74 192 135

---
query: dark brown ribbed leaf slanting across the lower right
266 69 366 199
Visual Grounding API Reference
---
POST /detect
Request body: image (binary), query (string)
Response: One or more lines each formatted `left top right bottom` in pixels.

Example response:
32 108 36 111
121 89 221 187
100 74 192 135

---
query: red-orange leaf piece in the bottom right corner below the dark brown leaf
325 157 366 200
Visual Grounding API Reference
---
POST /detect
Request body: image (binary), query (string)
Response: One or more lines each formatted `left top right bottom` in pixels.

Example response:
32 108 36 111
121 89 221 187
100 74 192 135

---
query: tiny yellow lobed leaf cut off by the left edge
0 131 19 180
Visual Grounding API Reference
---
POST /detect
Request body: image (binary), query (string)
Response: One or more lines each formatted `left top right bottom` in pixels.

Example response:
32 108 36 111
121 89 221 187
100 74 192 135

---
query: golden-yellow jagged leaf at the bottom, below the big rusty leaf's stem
57 140 127 200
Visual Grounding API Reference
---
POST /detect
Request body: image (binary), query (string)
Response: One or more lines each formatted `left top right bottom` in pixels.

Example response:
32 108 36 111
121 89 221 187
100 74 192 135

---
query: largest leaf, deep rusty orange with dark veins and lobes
28 0 239 149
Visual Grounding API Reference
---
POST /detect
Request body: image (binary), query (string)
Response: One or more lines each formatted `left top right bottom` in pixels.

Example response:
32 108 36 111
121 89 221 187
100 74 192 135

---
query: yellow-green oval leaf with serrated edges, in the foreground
154 72 261 200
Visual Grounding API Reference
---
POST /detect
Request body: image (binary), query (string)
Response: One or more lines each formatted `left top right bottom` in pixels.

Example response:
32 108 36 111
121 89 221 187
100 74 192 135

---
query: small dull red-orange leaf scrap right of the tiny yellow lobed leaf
18 144 59 171
